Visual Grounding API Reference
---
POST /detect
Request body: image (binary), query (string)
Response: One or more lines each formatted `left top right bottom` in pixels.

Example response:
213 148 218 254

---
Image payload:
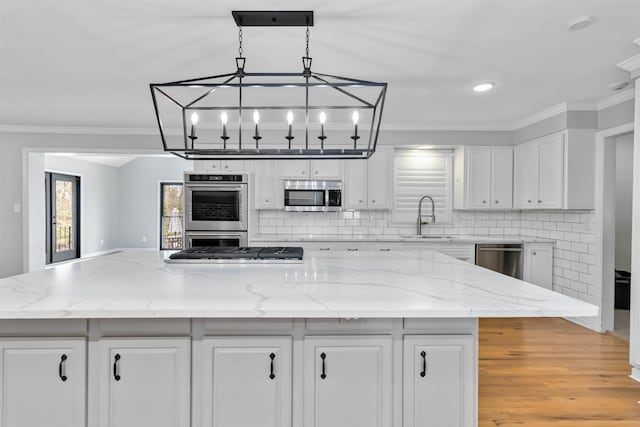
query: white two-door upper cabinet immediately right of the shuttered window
454 147 513 209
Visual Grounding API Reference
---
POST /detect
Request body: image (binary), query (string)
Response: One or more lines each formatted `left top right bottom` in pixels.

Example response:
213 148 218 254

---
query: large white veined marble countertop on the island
0 249 598 319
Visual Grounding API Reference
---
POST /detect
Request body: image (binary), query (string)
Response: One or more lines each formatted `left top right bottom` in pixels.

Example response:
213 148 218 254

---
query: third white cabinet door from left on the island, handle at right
194 337 291 427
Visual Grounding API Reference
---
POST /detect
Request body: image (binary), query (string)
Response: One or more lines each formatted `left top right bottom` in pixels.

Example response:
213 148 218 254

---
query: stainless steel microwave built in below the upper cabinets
284 180 342 212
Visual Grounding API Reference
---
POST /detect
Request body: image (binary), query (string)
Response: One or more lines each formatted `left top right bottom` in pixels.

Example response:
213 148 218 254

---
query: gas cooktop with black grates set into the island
165 246 304 264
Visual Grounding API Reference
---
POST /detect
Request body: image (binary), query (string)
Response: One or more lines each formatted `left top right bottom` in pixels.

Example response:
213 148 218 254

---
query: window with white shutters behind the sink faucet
393 150 453 223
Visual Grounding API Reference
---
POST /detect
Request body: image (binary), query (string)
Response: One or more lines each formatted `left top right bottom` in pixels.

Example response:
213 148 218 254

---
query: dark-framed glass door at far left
45 172 80 264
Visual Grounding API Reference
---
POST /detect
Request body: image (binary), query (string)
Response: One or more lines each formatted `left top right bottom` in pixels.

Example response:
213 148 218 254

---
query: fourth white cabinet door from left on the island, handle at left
304 336 392 427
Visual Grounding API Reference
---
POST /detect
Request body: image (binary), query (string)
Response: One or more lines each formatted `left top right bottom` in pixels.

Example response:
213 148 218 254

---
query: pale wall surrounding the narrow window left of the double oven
118 157 193 249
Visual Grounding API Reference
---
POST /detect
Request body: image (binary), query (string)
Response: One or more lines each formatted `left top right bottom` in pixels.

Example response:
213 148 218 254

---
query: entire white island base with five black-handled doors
0 318 478 427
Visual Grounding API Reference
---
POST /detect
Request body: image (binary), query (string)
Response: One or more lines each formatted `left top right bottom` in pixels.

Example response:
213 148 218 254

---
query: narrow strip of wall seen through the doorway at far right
615 133 633 271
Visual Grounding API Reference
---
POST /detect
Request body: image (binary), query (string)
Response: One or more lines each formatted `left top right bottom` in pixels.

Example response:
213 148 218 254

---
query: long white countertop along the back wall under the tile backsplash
249 234 554 244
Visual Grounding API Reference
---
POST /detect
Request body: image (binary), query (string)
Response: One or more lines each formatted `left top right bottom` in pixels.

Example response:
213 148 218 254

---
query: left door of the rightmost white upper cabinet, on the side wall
513 143 538 209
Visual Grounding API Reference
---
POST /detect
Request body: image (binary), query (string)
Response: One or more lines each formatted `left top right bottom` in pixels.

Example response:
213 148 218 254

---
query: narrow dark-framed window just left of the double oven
160 182 183 250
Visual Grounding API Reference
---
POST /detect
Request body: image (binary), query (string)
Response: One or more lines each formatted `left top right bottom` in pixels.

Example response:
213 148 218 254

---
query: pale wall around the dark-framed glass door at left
45 155 118 255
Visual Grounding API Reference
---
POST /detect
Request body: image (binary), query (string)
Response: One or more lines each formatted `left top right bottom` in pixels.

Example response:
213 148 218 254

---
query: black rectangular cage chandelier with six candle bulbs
150 11 387 160
